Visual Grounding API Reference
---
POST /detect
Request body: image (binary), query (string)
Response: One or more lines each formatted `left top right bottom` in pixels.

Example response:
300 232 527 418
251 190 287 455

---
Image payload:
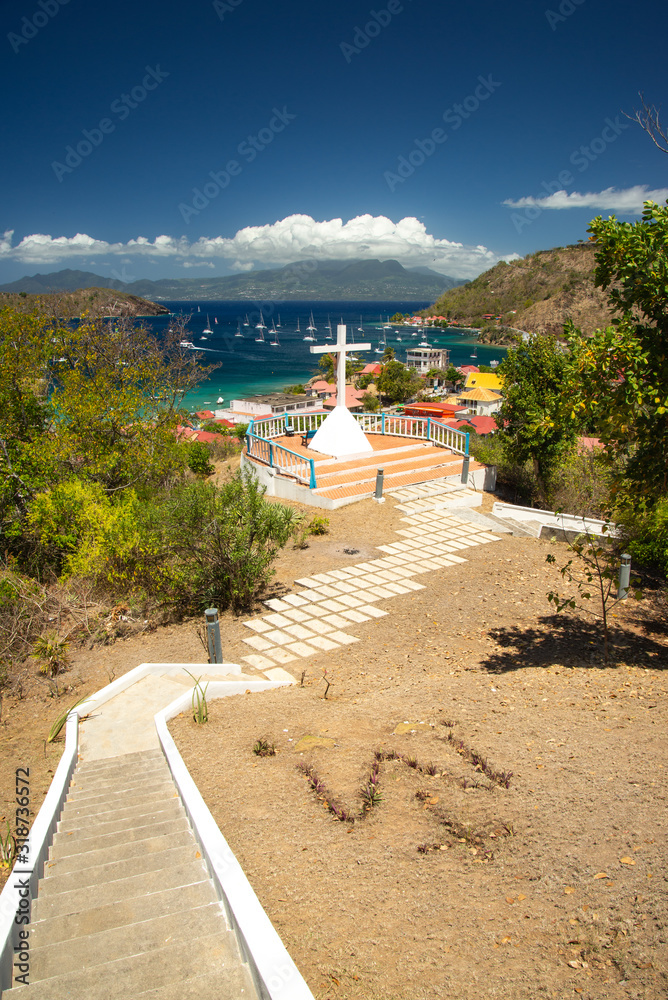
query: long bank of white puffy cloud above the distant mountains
0 215 517 278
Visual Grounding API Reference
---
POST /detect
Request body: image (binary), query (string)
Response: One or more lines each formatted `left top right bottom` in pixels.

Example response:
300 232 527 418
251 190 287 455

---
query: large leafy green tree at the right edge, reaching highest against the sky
567 202 668 504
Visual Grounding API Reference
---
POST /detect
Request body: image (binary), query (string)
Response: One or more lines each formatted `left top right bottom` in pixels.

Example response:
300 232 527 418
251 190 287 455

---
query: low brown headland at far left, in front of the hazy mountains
0 288 169 319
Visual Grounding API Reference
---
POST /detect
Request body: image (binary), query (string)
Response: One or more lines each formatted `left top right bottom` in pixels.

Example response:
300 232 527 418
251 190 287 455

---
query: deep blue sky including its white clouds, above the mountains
0 0 668 282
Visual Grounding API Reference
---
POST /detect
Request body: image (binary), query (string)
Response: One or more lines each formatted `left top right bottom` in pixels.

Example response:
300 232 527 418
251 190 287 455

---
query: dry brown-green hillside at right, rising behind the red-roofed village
424 243 612 334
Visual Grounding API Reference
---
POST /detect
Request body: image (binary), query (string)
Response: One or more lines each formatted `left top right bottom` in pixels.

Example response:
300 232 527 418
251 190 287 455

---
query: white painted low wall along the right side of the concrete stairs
155 681 313 1000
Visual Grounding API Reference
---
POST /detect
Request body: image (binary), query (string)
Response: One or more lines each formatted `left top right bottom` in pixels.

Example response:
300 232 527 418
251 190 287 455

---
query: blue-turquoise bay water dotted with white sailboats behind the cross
146 301 506 410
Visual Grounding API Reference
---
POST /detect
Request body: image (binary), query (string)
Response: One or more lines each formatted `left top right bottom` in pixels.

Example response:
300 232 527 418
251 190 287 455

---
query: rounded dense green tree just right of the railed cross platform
495 334 576 489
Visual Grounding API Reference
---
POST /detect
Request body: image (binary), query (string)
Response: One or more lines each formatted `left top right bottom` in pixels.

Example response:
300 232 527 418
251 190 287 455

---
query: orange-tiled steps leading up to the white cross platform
312 444 482 500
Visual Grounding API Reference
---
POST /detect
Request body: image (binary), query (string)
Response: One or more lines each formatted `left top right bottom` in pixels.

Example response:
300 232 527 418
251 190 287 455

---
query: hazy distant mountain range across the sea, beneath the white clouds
0 260 465 302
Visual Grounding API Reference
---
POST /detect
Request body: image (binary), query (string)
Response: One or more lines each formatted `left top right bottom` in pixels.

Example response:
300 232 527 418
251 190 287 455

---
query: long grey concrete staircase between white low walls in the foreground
6 750 258 1000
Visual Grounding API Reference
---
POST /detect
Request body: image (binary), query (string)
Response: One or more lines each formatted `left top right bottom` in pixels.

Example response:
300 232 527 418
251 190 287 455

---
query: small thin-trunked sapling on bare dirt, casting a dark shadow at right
545 524 642 664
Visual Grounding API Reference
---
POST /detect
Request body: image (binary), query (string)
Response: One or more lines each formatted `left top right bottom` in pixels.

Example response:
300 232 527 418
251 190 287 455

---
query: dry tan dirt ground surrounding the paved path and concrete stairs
0 498 668 1000
